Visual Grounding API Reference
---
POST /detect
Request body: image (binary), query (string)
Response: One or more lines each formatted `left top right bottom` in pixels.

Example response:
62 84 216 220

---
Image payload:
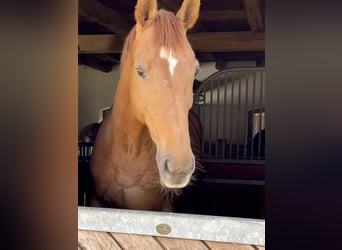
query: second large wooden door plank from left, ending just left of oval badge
111 233 163 250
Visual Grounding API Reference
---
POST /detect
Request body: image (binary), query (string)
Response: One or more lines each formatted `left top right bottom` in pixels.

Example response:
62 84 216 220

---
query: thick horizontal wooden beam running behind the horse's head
78 31 265 54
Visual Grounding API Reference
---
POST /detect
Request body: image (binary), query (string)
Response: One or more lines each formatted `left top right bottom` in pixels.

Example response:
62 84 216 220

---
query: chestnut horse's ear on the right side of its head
177 0 200 30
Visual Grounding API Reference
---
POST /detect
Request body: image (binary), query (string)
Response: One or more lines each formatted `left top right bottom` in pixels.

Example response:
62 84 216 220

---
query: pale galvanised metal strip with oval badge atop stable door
78 207 265 246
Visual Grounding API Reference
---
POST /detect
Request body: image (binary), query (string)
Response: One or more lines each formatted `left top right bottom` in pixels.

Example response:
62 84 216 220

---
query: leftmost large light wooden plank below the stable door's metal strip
78 230 122 250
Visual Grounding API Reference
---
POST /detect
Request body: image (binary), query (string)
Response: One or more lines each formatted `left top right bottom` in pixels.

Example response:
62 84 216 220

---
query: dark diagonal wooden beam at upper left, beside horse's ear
78 0 132 34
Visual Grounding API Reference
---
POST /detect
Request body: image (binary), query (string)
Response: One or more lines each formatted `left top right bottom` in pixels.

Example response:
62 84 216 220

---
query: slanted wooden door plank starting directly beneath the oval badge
156 237 209 250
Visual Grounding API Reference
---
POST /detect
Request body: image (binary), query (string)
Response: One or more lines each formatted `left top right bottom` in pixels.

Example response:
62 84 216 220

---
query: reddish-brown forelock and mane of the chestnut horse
121 9 186 66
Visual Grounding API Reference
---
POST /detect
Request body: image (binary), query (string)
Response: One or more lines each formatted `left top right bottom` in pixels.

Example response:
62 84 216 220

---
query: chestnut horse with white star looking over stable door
90 0 200 212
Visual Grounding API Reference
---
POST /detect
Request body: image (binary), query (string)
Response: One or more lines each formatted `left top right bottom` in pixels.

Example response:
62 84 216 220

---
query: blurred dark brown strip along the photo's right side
266 1 342 250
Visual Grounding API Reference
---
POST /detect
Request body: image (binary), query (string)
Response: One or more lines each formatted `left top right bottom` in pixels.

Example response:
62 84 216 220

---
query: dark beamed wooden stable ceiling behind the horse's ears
78 0 265 72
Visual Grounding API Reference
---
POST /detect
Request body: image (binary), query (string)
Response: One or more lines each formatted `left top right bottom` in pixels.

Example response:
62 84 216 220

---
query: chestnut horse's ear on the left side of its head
134 0 158 27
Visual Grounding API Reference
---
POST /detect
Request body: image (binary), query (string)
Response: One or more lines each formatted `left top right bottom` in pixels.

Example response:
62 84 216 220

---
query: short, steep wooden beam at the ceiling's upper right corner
243 0 265 31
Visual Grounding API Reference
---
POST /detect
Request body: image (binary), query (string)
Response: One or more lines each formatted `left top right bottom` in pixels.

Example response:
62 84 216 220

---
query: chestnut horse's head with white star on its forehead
123 0 200 188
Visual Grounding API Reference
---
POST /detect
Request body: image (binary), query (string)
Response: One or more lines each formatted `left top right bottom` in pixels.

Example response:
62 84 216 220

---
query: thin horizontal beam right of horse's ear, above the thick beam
199 10 246 21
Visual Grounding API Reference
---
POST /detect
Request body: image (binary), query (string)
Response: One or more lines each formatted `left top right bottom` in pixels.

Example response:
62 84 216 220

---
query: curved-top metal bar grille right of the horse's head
193 68 266 163
